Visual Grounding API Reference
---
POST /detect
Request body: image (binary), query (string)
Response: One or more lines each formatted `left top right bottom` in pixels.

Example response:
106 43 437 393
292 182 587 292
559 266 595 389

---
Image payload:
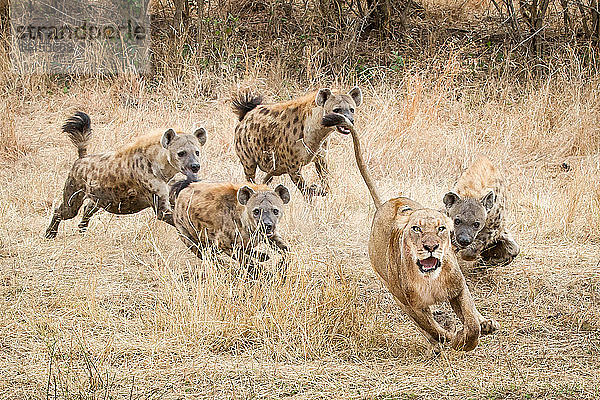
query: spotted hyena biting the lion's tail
233 87 362 198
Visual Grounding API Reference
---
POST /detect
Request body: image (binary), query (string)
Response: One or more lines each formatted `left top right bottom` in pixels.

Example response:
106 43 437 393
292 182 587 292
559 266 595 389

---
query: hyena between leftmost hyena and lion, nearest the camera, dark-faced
173 182 289 272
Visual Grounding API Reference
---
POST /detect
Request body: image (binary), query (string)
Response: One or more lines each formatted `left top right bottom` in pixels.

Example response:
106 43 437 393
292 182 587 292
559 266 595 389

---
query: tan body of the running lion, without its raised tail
369 197 498 351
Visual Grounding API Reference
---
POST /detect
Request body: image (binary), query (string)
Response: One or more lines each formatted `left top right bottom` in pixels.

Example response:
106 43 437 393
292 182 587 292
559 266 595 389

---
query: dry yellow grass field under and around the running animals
0 54 600 399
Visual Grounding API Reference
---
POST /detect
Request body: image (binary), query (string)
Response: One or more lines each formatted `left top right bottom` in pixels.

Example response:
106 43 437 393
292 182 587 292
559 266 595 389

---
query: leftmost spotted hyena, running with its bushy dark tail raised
46 112 206 239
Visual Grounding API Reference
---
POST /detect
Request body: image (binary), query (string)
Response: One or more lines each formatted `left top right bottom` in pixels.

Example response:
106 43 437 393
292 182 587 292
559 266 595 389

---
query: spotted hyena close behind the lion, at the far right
444 156 519 265
